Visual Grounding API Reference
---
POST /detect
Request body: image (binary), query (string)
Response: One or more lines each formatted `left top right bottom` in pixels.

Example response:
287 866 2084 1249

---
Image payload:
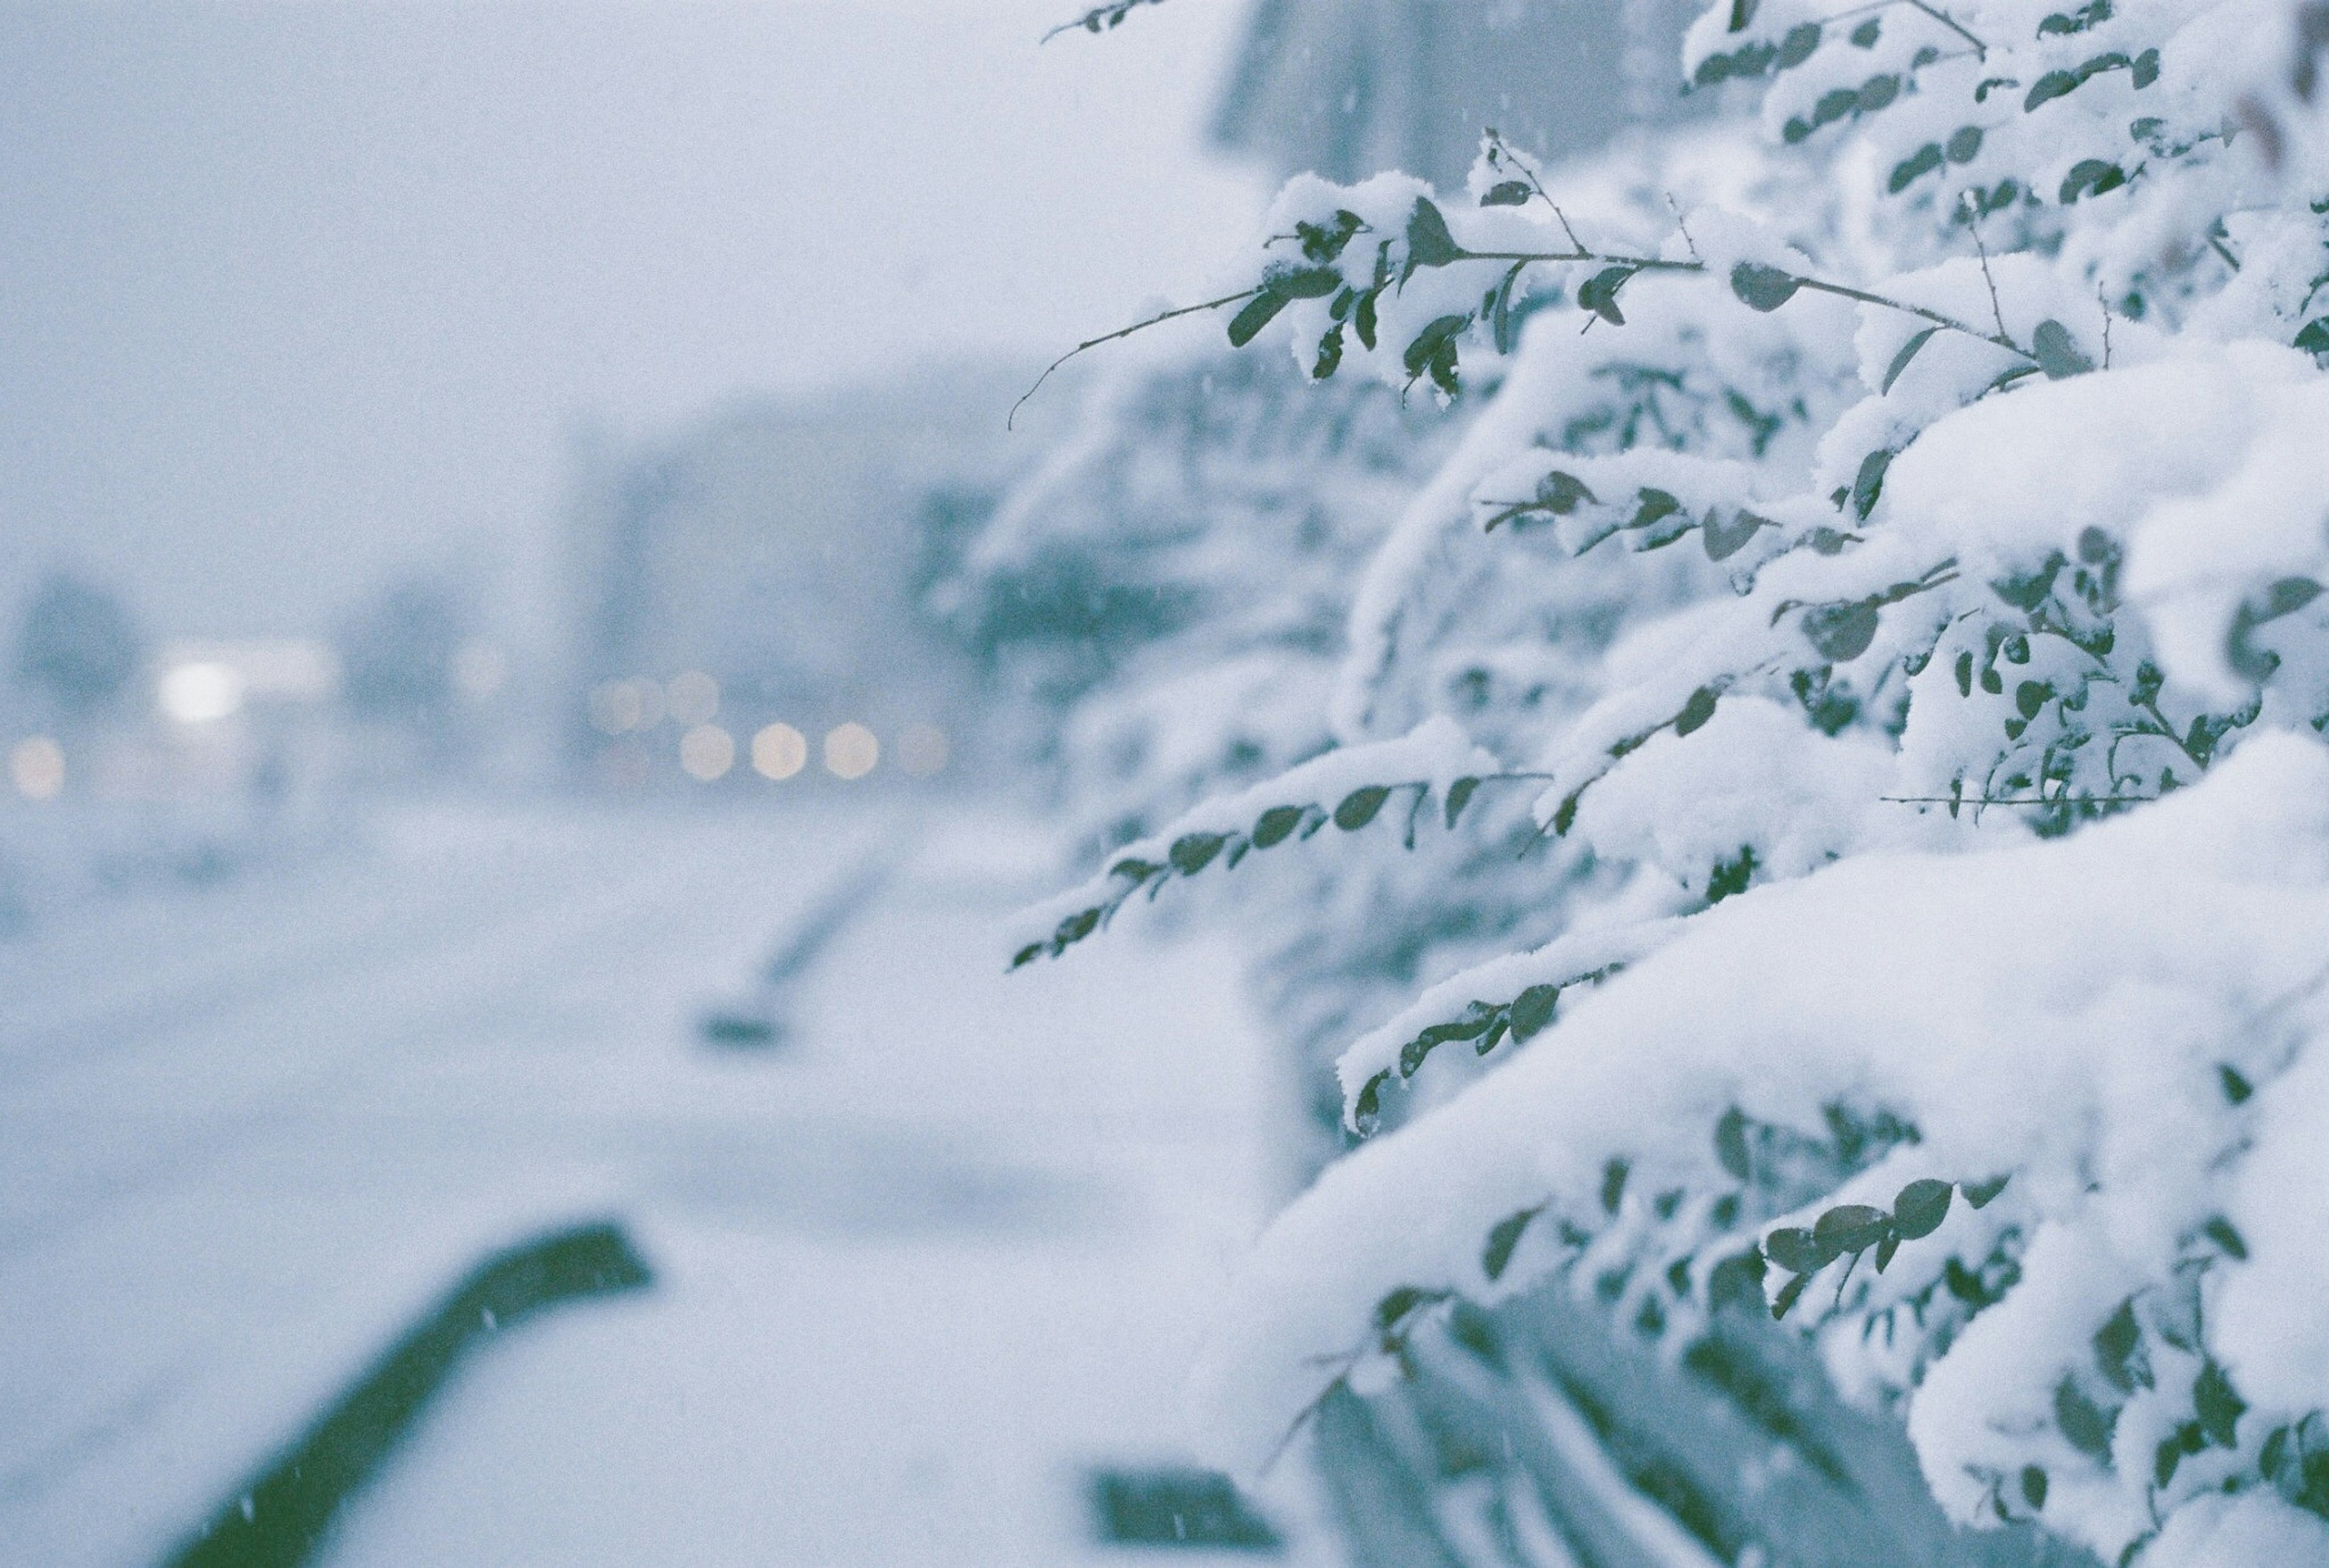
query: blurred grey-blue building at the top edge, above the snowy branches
1214 0 1705 186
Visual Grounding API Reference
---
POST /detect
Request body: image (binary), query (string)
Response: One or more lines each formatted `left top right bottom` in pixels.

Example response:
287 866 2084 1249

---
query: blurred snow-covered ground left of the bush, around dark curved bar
0 806 1323 1568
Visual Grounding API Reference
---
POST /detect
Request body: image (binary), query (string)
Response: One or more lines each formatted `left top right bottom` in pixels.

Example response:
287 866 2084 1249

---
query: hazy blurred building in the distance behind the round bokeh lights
568 370 1034 788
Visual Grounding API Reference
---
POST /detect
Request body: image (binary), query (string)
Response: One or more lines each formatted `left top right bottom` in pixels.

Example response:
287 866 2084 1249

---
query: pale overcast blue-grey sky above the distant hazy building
0 0 1262 634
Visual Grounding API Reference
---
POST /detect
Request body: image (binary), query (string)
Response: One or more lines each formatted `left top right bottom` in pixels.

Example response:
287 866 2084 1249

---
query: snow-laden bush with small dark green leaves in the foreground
1013 0 2329 1566
